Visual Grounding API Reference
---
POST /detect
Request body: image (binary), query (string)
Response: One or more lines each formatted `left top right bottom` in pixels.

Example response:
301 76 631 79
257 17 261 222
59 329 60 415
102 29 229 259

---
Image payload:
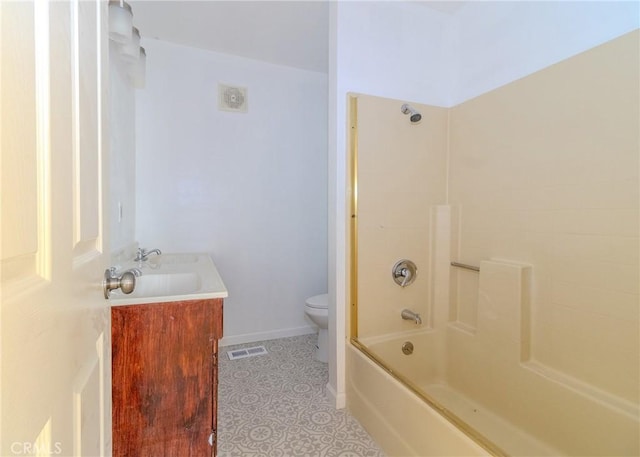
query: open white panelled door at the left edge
0 0 111 456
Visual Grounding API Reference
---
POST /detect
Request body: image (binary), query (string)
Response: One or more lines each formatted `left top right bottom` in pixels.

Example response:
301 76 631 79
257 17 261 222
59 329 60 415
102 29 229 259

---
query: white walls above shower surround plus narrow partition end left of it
328 2 639 407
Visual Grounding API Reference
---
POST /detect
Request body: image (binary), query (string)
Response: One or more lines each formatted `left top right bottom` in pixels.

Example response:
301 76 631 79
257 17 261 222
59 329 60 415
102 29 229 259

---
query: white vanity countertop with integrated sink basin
109 252 229 306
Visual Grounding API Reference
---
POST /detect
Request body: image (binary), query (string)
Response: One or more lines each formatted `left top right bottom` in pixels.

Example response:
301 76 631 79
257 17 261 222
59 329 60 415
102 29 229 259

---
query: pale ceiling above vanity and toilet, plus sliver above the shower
130 0 468 73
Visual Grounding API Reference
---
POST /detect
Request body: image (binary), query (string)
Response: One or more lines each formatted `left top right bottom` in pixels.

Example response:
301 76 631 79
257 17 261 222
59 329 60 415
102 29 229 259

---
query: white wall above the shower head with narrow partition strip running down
327 2 450 407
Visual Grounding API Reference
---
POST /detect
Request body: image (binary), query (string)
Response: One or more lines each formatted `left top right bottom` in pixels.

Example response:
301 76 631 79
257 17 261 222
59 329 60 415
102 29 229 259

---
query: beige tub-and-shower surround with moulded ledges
347 31 640 455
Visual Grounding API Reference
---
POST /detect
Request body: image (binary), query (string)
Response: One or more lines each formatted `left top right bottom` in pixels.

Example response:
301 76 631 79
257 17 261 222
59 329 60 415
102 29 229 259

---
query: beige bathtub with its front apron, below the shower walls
347 326 638 456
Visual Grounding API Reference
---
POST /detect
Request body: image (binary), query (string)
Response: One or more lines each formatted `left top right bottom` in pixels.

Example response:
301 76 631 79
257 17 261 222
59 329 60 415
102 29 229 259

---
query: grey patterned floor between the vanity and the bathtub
218 335 384 457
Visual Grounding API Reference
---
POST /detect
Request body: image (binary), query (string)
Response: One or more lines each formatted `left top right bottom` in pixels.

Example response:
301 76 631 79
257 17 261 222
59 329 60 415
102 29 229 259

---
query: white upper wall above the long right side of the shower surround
449 1 640 106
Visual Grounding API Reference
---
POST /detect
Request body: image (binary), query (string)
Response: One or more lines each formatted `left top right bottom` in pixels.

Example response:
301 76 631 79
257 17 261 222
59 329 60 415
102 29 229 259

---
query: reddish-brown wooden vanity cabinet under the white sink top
111 299 223 457
